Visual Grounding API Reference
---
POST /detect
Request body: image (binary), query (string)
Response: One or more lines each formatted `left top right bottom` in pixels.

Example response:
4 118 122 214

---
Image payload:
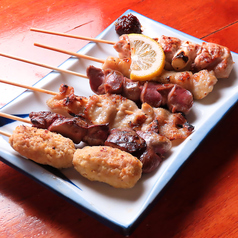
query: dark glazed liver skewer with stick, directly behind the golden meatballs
0 112 172 173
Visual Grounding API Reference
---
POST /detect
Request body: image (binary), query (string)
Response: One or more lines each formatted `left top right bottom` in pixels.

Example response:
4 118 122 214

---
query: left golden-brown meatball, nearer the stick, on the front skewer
9 125 75 169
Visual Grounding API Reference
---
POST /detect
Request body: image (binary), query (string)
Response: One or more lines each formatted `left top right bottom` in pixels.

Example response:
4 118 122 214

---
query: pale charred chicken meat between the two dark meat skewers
0 79 193 140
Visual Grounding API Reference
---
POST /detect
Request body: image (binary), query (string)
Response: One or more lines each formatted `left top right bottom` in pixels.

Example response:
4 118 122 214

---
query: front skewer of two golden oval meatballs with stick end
0 125 142 189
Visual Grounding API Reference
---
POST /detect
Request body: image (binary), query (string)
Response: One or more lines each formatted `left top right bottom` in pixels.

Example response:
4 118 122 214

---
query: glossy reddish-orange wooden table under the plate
0 0 238 238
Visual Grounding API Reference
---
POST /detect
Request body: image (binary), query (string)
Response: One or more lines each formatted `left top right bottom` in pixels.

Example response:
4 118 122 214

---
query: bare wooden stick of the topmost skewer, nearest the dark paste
30 28 115 45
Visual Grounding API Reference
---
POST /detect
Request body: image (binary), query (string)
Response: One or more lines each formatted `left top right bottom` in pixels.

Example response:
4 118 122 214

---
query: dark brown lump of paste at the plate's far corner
115 13 142 36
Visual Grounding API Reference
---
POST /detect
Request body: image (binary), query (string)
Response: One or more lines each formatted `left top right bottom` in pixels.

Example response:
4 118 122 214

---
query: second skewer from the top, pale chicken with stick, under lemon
33 44 217 100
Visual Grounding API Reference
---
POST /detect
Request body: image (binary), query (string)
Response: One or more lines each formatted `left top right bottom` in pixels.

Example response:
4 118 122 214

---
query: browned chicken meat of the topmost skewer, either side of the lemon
114 35 234 78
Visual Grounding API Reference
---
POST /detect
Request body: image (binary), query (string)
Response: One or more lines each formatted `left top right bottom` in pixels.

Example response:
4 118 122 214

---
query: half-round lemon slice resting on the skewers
128 34 165 81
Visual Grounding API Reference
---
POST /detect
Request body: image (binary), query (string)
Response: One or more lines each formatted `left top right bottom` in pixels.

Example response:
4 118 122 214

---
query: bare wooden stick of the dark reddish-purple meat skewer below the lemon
0 53 88 78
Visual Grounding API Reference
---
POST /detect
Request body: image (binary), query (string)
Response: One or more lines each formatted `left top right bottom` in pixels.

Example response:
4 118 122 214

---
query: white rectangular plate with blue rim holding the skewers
0 10 238 235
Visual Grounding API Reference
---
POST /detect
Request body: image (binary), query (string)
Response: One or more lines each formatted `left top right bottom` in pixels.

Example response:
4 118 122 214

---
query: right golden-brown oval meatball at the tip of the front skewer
73 146 142 188
